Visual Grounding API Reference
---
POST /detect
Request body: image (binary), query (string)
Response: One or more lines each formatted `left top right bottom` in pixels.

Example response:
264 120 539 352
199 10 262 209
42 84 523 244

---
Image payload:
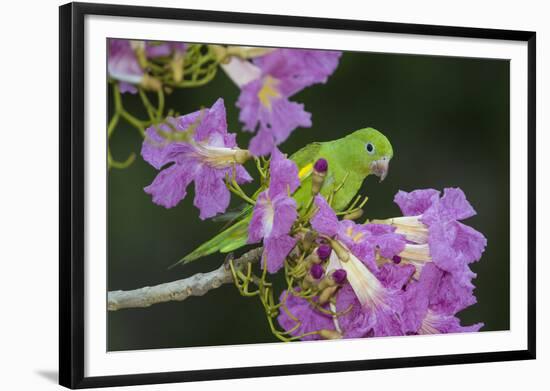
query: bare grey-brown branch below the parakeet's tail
107 247 263 311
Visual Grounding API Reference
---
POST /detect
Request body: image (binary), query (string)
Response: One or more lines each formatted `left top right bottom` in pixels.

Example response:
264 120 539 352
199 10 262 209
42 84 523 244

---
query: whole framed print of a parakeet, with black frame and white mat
60 3 536 388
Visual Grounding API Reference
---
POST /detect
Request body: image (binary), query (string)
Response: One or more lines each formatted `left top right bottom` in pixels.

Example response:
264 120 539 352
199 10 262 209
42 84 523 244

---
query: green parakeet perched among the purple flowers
178 128 393 263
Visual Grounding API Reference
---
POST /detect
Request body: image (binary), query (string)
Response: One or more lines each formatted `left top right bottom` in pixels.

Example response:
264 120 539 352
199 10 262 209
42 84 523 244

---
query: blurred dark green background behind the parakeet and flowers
107 49 510 350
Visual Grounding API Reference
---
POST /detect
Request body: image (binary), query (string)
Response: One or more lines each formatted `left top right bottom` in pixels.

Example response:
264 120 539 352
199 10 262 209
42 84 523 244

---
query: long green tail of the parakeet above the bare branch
170 217 250 268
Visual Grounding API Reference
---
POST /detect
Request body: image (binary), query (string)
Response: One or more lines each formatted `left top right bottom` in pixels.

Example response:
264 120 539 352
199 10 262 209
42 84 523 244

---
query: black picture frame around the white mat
59 3 536 388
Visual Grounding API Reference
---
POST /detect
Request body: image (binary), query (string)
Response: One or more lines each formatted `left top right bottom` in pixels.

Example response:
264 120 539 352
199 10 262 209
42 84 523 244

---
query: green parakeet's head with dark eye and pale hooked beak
346 128 393 181
